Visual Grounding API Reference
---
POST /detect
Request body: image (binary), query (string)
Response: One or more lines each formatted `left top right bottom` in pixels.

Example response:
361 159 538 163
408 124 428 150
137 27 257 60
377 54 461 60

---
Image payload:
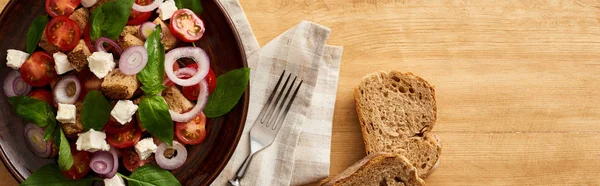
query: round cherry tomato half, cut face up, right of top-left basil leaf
45 16 81 51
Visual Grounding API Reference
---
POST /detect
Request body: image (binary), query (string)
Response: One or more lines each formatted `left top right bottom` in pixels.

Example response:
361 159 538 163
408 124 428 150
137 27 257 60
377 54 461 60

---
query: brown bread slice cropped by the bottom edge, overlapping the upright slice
323 152 425 186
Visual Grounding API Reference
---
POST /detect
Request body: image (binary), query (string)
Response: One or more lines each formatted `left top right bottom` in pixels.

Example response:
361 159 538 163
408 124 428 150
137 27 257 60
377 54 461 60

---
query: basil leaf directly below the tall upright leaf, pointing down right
138 95 173 145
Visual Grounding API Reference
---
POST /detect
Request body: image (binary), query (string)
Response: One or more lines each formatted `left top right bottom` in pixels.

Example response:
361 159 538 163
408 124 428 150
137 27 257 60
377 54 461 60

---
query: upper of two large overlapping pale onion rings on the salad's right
165 47 210 86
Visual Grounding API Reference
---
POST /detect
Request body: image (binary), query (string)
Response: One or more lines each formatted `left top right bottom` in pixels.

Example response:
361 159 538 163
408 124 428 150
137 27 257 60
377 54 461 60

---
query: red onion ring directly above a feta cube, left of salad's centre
52 75 81 104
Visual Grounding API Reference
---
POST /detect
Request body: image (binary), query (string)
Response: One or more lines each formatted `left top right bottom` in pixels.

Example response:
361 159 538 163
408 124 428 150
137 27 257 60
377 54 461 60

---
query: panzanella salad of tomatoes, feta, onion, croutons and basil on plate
3 0 250 185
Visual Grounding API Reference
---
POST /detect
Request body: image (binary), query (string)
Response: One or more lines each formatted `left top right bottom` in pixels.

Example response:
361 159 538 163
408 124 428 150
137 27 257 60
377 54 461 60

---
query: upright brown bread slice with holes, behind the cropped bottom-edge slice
354 71 442 178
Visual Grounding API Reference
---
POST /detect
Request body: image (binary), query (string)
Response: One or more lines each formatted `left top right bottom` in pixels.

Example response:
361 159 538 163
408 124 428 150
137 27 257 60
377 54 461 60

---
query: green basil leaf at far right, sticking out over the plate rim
204 68 250 118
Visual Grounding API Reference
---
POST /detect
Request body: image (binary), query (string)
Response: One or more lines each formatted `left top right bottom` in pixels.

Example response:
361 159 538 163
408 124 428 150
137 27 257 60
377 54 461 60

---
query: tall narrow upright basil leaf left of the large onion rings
137 25 166 95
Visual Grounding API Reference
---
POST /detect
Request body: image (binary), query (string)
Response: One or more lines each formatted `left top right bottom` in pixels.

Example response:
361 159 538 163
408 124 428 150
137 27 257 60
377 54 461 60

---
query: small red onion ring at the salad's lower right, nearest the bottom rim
154 141 187 170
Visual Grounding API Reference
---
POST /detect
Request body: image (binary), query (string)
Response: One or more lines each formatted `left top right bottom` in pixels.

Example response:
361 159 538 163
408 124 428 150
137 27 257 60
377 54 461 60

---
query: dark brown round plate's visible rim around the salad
0 0 249 185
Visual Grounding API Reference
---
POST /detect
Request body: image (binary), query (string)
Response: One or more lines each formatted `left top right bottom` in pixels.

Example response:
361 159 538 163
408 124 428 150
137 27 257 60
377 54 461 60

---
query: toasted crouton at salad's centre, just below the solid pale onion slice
102 69 140 100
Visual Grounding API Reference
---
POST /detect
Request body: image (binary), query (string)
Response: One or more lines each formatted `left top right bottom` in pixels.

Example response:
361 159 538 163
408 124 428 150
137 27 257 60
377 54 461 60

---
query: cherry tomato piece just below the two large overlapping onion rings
175 112 206 145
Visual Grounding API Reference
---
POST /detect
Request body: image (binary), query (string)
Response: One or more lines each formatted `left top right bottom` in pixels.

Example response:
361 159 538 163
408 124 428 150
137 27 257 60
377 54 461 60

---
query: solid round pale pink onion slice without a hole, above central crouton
119 46 148 75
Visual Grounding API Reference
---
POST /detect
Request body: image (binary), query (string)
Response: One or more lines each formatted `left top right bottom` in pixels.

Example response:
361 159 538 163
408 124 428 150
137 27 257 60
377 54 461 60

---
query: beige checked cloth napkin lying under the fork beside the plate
212 0 342 186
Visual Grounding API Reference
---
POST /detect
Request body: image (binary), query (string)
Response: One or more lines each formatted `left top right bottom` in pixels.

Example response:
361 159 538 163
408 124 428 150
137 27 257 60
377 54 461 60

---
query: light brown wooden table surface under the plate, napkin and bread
0 0 600 186
